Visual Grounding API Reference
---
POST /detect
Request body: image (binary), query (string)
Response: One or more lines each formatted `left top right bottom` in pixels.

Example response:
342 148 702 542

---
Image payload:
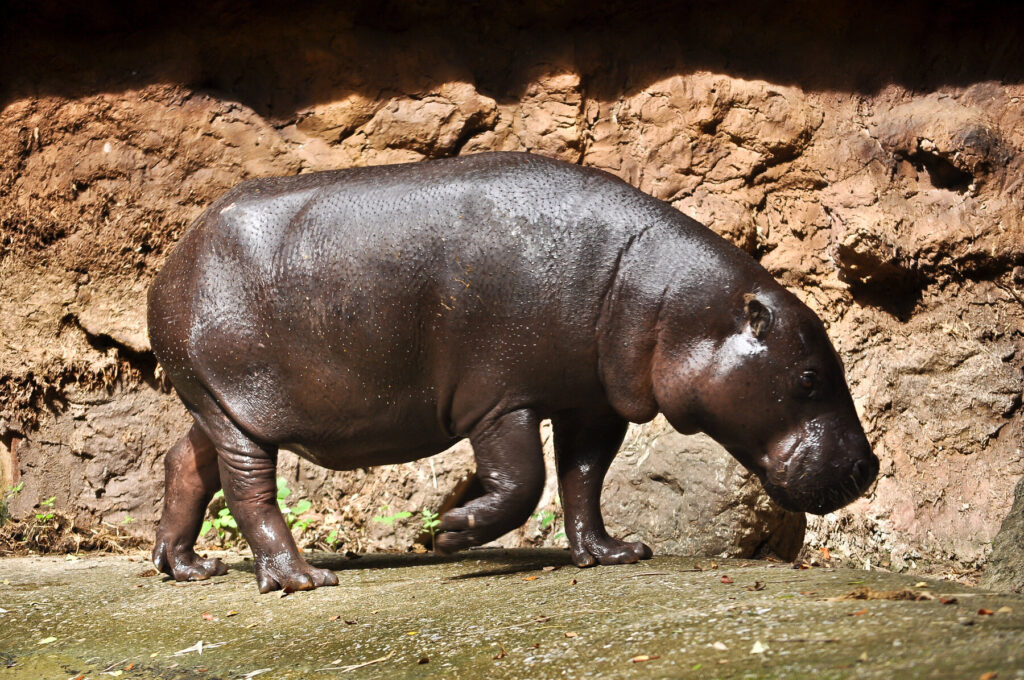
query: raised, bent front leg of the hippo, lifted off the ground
434 410 544 553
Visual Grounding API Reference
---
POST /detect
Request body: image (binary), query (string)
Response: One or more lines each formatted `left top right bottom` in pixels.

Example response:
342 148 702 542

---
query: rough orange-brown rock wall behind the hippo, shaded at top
0 1 1024 568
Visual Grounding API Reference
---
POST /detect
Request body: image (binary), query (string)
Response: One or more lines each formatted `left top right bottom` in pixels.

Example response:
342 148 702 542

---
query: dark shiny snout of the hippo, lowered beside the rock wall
762 428 879 515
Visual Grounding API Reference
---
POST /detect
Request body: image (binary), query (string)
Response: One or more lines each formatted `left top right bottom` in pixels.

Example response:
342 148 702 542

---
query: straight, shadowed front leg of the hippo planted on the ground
551 412 651 566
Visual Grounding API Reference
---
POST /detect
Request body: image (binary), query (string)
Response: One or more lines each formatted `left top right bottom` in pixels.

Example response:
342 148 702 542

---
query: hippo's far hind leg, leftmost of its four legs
153 425 227 581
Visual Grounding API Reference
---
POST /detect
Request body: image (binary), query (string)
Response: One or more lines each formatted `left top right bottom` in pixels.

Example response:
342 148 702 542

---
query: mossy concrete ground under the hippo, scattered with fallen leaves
0 550 1024 680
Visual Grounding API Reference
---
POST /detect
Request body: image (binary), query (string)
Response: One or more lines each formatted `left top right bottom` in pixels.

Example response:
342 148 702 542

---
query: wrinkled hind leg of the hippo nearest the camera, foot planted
217 438 338 593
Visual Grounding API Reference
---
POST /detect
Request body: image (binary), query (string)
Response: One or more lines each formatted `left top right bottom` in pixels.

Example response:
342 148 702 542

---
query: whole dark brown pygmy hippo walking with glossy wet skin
148 154 878 592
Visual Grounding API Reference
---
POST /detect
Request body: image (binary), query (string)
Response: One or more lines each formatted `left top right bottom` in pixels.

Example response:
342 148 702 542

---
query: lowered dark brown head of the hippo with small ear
651 289 879 514
